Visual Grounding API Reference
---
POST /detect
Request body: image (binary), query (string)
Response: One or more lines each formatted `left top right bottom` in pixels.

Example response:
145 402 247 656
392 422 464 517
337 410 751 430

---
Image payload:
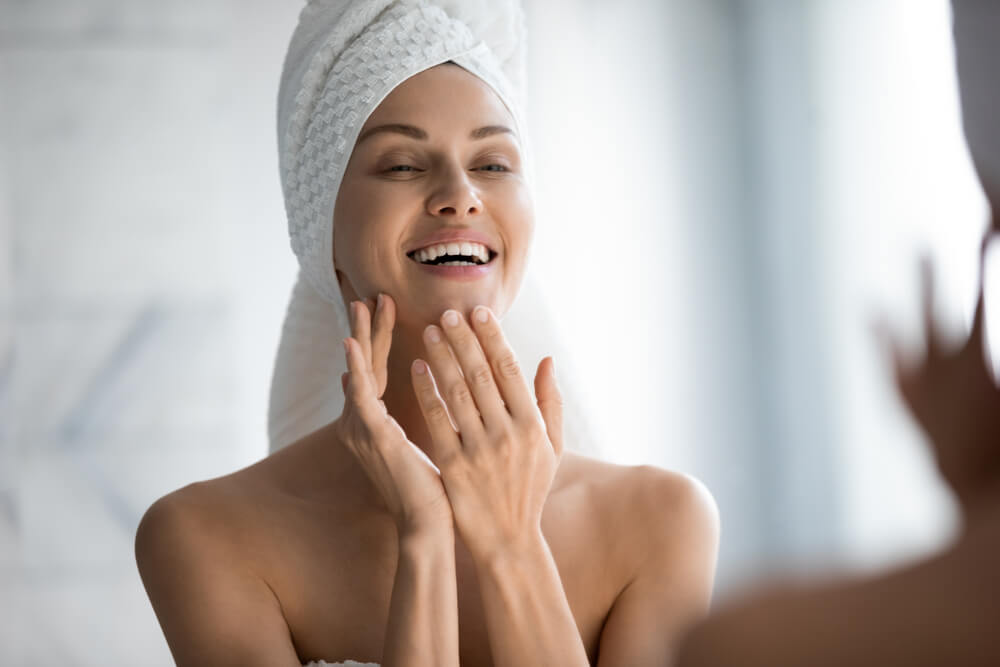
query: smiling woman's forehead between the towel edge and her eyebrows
362 63 514 136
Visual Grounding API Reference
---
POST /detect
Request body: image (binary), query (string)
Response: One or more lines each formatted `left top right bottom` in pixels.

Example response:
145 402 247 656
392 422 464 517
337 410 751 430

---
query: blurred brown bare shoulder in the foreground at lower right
678 516 1000 667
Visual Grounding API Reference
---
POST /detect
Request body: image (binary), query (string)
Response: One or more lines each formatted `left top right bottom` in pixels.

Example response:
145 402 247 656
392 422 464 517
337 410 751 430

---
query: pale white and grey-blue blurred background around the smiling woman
0 0 1000 666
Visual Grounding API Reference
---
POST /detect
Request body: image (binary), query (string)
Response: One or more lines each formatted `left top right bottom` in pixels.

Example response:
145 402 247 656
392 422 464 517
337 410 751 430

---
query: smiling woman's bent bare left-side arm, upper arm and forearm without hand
136 485 458 667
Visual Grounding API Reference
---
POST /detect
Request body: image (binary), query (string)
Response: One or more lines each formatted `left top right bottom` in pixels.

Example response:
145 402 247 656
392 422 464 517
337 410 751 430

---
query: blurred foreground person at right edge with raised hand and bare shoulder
678 0 1000 667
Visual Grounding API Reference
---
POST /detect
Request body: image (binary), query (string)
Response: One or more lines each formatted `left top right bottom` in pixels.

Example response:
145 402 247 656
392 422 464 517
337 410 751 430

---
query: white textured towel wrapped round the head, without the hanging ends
278 0 524 306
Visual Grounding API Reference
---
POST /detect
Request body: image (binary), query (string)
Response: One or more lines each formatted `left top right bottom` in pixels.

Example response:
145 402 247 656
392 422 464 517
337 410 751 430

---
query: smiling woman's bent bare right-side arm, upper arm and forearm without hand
468 467 718 667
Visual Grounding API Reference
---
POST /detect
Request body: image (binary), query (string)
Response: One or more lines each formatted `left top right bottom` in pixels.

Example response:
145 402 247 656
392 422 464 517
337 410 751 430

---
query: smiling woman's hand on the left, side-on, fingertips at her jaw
334 294 453 537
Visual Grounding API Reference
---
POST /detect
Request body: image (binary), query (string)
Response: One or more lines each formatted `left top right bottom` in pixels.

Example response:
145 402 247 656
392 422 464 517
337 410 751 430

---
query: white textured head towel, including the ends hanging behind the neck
268 0 597 452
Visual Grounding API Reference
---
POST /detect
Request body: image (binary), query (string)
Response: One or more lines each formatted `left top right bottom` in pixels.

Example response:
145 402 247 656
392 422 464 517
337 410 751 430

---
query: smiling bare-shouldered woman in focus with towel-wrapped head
136 0 718 666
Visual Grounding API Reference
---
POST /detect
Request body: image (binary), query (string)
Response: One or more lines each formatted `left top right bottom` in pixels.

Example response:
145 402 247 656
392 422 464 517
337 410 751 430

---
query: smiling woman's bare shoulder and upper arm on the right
567 456 719 665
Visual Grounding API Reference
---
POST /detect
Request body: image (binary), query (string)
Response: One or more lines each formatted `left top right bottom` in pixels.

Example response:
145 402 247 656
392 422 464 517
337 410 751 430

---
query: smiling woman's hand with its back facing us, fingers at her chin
413 306 563 562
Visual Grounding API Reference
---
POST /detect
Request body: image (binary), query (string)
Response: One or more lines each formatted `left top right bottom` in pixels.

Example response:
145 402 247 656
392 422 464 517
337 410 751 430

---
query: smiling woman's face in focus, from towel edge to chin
333 64 534 327
